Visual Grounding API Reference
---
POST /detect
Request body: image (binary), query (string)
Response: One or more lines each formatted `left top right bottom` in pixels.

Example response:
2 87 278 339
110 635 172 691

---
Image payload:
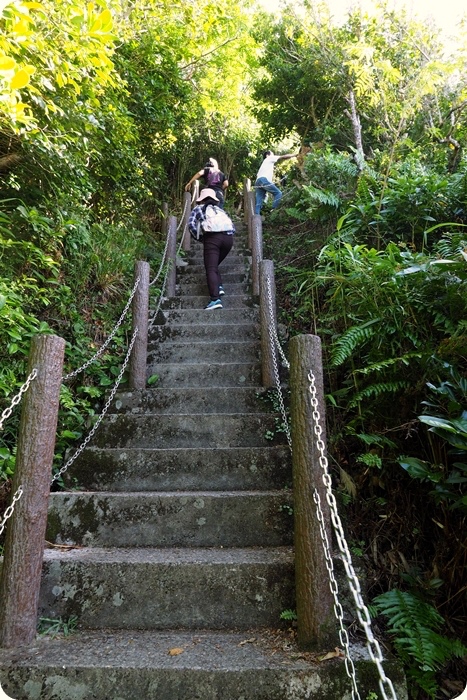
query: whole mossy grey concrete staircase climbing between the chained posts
0 230 406 700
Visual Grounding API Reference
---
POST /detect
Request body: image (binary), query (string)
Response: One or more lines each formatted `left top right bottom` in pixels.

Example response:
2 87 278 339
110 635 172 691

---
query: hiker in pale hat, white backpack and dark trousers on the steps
188 187 235 311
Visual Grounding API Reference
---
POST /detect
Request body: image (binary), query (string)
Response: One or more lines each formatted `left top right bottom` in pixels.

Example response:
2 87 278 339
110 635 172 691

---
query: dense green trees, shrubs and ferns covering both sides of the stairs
0 0 467 698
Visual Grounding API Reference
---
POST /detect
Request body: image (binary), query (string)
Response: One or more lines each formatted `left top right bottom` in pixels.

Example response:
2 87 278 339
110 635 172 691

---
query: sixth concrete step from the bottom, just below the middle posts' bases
111 386 272 415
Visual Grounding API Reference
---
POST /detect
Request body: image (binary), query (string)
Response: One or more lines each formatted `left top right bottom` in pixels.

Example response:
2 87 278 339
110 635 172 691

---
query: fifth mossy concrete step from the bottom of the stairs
94 413 285 449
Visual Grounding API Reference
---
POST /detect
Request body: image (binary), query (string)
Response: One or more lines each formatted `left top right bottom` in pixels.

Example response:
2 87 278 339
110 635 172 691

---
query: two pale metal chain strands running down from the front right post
308 370 397 700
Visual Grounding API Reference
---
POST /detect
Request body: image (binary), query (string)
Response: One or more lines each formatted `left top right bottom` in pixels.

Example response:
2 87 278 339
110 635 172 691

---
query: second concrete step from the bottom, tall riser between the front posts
39 547 295 629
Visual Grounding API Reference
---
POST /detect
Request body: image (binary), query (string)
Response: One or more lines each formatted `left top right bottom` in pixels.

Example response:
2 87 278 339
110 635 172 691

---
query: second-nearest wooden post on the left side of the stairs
128 260 149 389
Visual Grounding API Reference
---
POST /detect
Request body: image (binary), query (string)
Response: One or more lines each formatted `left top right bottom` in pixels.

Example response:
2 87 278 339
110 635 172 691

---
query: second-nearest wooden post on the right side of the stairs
259 260 277 387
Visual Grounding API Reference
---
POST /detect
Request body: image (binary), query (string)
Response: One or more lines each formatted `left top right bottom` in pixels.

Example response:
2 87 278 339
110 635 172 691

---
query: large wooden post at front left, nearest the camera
0 335 65 647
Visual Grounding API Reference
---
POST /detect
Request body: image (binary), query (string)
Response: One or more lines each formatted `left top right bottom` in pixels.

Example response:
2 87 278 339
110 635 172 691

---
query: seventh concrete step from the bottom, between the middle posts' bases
147 362 261 388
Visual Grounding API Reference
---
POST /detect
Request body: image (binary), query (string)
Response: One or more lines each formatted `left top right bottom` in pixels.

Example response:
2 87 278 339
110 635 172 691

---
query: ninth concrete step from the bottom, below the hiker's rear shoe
148 322 260 344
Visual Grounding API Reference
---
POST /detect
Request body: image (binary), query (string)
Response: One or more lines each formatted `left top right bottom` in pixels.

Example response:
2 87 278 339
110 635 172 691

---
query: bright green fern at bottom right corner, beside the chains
373 589 467 698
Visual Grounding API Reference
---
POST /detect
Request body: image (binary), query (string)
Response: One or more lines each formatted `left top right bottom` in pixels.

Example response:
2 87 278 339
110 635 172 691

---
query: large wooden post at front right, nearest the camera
289 335 337 649
